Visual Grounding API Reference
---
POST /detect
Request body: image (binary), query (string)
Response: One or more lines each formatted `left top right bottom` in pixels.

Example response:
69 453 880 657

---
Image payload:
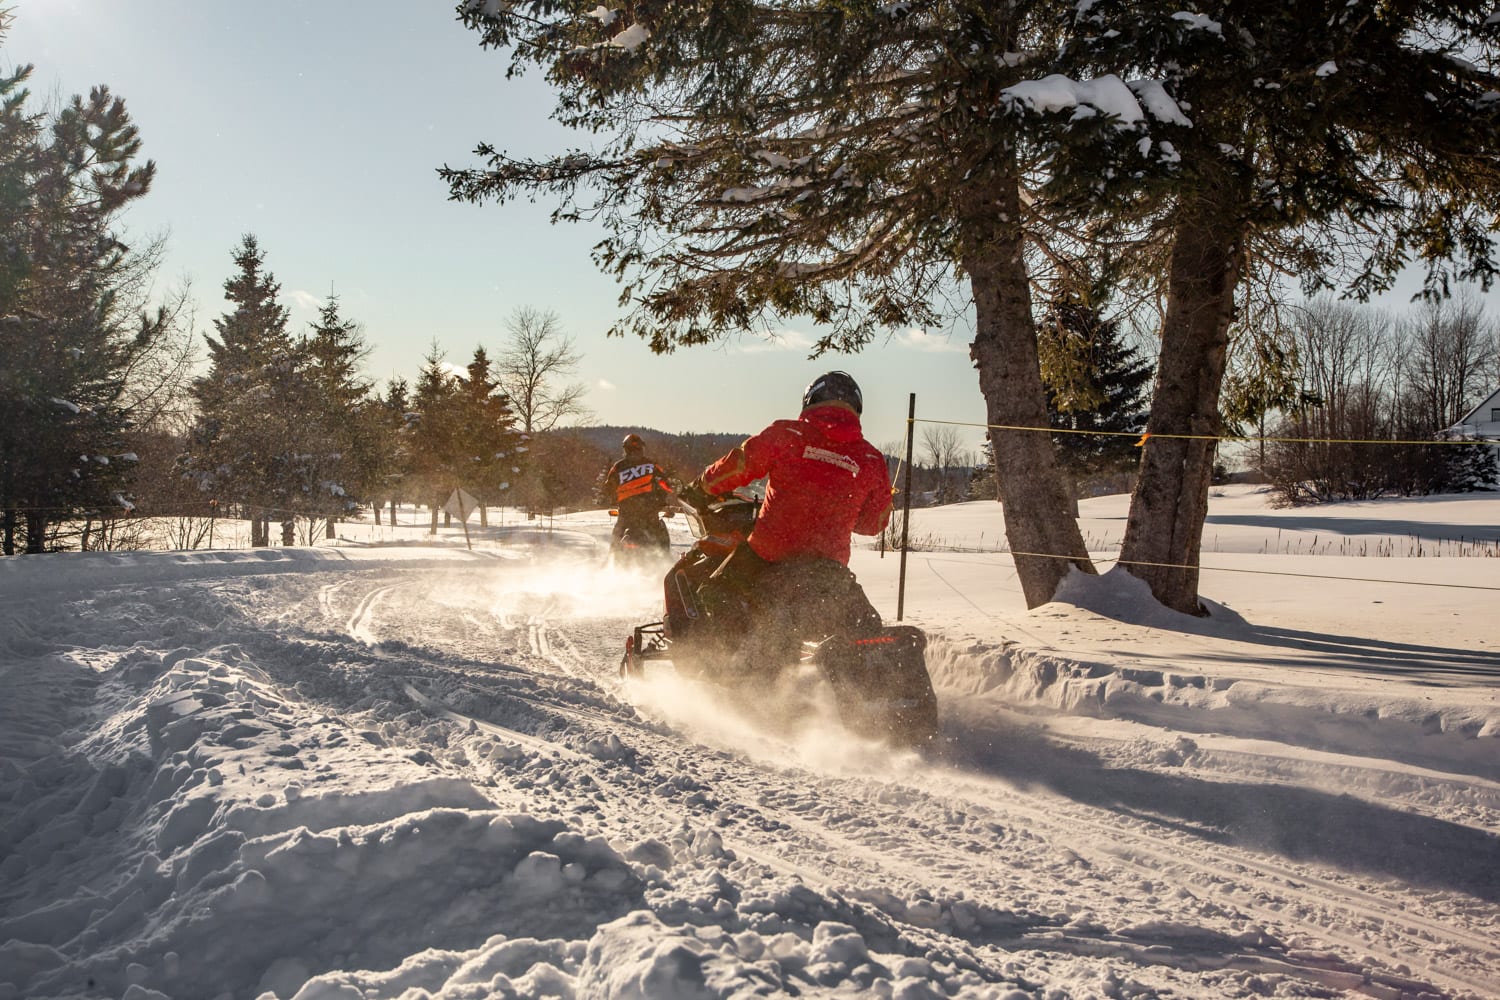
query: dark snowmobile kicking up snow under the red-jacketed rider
620 490 938 748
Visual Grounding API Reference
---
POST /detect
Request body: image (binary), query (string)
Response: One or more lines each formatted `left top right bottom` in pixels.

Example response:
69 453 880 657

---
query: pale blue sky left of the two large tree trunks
0 0 984 447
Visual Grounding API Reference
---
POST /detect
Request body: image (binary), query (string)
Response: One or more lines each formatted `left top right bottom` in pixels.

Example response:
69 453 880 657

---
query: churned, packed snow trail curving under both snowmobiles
0 539 1500 999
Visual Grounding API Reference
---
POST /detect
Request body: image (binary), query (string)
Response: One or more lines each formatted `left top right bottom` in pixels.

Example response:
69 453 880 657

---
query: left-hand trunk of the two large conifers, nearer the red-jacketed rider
963 177 1095 607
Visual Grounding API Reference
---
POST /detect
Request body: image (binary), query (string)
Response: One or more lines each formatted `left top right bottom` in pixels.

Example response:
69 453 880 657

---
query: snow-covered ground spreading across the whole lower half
0 487 1500 1000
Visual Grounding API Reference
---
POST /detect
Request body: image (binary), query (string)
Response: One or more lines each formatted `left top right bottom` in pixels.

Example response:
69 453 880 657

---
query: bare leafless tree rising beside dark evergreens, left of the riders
497 306 590 435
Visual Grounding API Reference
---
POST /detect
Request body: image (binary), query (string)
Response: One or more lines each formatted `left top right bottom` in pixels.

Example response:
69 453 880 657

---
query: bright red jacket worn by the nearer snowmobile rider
704 403 891 565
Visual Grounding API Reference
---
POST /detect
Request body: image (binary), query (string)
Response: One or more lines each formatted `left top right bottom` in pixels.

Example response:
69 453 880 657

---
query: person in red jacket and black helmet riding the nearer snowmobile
696 372 891 644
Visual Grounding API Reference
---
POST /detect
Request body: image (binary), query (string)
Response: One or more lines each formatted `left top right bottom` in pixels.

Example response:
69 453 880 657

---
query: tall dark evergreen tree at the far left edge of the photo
0 17 162 555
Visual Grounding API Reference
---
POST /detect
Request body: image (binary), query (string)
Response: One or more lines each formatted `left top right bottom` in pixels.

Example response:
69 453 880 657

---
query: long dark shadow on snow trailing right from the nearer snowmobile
948 723 1500 903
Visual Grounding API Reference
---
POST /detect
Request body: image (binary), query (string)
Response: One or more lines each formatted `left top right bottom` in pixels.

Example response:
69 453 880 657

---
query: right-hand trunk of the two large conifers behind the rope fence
1121 202 1245 615
